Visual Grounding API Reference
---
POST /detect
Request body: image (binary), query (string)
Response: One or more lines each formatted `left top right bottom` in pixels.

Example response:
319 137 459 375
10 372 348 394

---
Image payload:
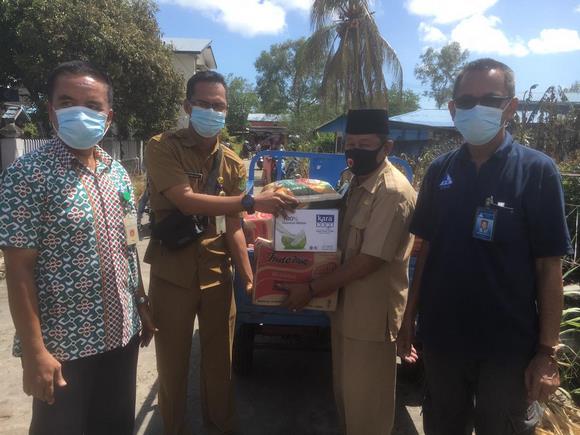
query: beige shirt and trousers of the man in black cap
331 162 416 435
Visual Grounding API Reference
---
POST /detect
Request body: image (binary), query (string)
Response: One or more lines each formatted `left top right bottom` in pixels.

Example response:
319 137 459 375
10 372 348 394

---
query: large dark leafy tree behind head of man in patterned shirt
0 0 183 138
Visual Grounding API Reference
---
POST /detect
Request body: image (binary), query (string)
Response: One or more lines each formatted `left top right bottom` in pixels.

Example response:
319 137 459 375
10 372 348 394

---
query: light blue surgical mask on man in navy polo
453 105 503 145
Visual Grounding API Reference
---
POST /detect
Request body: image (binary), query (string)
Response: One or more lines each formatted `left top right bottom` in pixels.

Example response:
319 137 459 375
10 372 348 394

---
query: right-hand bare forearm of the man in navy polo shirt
536 257 564 347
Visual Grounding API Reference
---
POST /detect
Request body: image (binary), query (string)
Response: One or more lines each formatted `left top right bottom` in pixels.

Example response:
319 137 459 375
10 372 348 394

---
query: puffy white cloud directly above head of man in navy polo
451 15 529 57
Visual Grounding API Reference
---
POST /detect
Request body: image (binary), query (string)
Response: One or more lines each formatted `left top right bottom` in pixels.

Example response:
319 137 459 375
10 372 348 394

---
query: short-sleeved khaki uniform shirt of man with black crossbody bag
144 128 246 290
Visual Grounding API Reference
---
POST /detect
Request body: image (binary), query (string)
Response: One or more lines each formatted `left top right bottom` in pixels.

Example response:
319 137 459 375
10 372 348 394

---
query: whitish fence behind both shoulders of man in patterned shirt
0 138 143 173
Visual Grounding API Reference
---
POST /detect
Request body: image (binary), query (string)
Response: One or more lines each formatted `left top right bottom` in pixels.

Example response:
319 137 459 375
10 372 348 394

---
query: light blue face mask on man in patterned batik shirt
55 106 107 150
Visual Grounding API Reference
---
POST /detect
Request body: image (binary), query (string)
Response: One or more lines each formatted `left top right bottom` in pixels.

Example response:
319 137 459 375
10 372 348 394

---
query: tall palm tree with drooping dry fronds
303 0 403 110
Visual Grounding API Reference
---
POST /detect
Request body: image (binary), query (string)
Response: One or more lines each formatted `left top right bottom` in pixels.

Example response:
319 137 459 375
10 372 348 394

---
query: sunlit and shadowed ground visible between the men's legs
0 241 423 435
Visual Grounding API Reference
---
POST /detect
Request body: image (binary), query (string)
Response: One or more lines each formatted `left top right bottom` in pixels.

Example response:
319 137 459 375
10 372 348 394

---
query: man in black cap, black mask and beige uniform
286 110 416 435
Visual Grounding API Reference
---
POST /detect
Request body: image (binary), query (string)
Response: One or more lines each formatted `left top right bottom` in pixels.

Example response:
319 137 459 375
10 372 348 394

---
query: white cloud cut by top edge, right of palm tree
405 0 498 24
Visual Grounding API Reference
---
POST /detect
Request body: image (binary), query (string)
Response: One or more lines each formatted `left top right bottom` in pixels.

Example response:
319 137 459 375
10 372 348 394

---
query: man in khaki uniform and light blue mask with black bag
145 71 295 434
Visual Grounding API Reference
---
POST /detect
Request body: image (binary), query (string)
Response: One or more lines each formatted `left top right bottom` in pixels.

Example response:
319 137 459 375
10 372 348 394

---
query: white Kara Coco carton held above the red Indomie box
274 209 338 252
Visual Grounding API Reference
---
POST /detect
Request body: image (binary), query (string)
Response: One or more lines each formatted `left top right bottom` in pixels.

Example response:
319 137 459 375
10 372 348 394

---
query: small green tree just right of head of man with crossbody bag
226 74 259 134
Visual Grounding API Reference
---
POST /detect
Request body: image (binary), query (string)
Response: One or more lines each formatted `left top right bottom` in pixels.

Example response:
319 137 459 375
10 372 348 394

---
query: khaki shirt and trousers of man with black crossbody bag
145 128 246 434
